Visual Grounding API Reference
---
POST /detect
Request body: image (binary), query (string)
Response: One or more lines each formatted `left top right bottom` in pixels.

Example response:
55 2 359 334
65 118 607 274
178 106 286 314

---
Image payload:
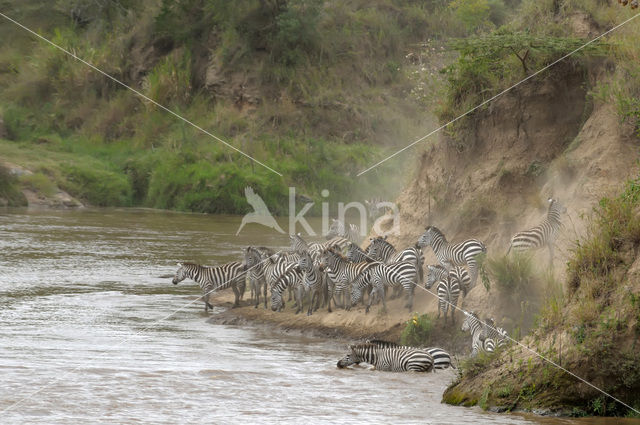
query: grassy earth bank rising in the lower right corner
445 169 640 416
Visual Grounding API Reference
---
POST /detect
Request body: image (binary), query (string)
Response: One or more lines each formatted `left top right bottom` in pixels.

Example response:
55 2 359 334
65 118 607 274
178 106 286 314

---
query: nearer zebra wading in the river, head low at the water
337 343 433 372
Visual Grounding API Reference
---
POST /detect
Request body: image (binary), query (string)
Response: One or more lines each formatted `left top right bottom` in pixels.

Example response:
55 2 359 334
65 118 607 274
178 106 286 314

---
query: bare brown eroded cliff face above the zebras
392 60 640 321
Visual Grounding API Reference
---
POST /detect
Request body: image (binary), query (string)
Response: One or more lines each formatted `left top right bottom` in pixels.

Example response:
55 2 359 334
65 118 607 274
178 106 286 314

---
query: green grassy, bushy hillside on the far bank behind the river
0 0 464 213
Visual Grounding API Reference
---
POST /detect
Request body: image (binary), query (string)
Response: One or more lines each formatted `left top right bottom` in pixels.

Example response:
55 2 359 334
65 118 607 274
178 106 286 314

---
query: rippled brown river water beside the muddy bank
0 209 639 425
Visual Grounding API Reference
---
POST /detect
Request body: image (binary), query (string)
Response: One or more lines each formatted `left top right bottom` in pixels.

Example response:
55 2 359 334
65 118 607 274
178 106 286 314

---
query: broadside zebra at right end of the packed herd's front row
362 261 417 313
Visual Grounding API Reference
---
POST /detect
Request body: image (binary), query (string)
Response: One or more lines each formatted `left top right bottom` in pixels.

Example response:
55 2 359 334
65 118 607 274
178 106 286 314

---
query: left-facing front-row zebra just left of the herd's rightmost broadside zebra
320 248 375 309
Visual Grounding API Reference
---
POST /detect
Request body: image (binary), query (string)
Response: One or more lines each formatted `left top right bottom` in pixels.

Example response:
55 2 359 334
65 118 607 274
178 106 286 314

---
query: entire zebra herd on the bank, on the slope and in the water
173 199 566 364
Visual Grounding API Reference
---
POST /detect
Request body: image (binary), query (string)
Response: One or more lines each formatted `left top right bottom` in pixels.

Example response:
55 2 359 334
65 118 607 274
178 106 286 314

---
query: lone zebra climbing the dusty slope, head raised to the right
507 198 567 266
